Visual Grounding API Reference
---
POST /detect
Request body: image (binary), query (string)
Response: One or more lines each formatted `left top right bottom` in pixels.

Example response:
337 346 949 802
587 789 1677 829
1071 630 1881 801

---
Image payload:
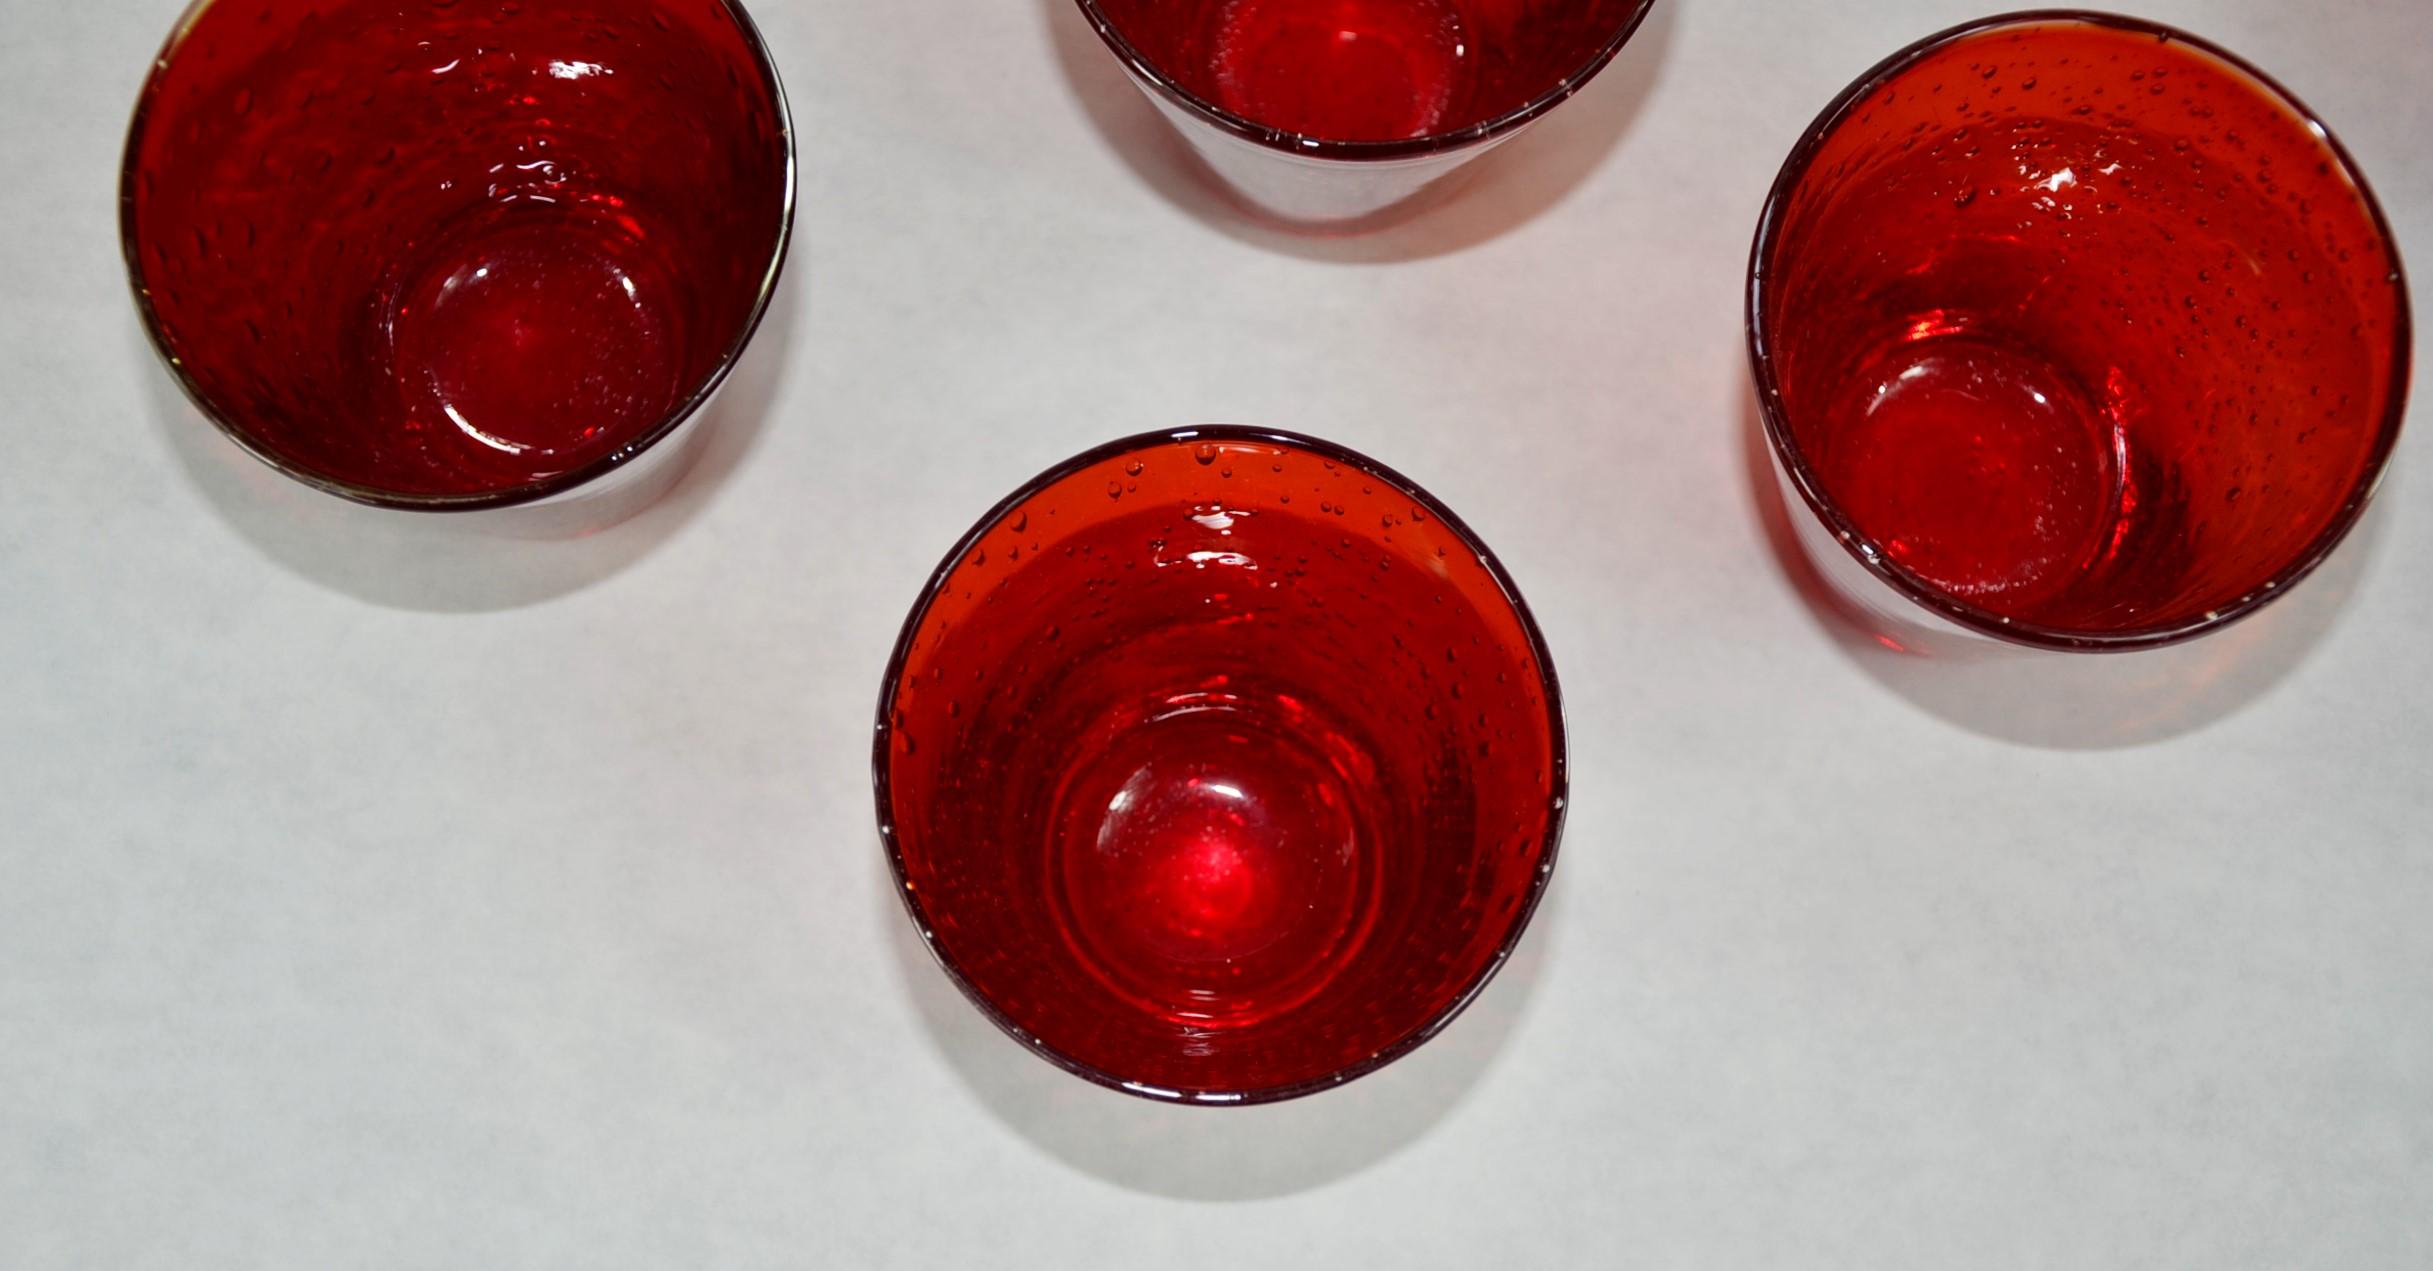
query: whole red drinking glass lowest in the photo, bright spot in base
873 429 1564 1103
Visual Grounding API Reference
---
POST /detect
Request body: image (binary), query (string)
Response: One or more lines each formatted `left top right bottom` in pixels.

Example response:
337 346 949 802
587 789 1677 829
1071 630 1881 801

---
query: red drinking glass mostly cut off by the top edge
1078 0 1654 222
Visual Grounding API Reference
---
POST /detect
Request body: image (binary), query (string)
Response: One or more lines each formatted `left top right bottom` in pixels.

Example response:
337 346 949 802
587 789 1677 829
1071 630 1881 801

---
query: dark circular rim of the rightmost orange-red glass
1744 10 2414 653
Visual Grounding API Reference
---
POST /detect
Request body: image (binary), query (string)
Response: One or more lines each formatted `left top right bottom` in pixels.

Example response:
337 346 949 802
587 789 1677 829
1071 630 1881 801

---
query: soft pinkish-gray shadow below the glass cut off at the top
1039 0 1681 263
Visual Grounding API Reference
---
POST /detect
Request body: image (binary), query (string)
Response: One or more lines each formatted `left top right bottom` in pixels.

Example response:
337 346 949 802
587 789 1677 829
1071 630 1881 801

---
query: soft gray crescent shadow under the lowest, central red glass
878 850 1562 1200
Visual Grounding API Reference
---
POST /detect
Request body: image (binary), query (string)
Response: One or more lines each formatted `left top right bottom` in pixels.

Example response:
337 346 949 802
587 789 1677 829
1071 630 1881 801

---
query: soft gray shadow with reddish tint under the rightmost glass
1740 390 2392 750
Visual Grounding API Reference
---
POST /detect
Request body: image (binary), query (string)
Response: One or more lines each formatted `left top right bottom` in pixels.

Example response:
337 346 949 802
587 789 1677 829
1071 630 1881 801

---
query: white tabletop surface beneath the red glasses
0 0 2433 1271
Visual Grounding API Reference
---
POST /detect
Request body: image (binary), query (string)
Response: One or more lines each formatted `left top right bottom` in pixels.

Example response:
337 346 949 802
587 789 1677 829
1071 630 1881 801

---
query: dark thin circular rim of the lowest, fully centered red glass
871 424 1572 1108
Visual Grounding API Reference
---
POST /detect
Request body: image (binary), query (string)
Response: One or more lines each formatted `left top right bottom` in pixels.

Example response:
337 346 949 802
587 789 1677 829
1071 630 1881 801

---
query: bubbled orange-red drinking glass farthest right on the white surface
1749 12 2409 650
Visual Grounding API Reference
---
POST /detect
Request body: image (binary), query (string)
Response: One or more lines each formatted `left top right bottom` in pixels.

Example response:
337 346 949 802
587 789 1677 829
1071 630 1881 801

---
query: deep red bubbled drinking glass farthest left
119 0 793 509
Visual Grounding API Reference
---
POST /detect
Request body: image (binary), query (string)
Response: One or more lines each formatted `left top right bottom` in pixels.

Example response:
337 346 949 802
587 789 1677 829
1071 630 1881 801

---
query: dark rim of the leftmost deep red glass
119 0 800 511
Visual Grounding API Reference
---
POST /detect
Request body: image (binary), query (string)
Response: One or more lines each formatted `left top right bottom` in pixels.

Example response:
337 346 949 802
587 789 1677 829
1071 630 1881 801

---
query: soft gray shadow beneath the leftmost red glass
129 260 800 614
